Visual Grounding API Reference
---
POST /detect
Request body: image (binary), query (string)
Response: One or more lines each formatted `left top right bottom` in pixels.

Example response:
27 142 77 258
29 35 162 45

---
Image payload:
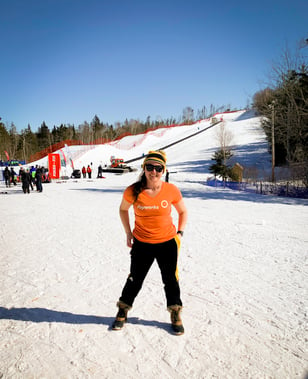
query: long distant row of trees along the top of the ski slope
0 105 230 162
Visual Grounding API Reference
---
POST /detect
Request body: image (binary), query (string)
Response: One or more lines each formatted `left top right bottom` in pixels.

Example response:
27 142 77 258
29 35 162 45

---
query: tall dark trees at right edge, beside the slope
253 40 308 180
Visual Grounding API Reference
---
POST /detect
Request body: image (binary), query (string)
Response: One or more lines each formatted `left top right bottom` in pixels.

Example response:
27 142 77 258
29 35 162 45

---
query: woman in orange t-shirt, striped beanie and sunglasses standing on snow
112 151 187 335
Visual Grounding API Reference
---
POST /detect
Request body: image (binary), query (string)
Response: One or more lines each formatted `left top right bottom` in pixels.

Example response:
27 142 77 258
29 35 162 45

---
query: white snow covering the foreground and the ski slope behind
0 112 308 379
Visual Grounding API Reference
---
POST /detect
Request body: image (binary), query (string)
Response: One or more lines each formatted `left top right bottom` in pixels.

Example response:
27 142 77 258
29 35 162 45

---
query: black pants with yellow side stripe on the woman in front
120 238 182 307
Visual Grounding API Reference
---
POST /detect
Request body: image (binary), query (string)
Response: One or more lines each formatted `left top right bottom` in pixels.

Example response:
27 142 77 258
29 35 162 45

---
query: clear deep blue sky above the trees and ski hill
0 0 308 131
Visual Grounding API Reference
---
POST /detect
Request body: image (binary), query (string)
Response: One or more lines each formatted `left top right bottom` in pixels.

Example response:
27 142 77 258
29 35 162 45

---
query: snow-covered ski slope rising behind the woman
30 111 271 183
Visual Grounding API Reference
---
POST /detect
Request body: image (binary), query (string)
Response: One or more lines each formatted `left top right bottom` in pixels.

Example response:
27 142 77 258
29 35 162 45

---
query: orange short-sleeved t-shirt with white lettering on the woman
123 182 182 243
